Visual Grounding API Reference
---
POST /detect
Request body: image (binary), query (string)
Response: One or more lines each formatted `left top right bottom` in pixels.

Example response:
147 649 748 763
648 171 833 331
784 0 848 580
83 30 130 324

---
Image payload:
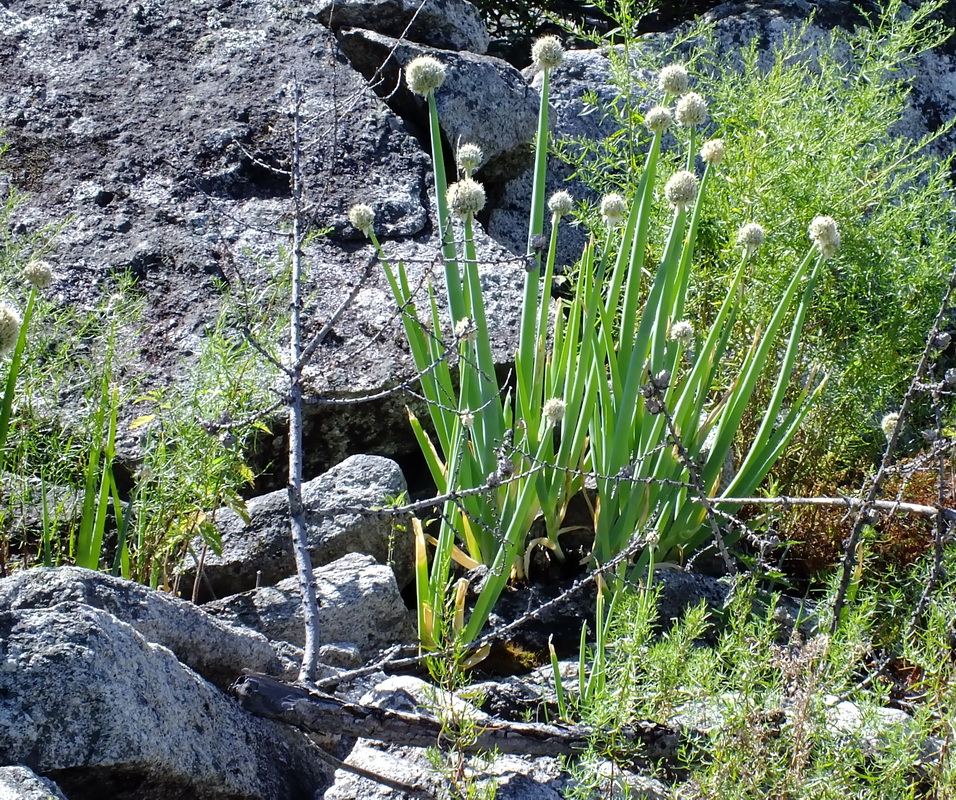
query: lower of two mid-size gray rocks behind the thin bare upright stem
203 553 415 661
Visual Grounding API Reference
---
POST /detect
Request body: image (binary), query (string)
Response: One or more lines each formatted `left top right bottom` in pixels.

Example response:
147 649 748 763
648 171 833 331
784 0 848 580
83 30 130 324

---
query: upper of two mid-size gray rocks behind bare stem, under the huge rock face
181 456 414 600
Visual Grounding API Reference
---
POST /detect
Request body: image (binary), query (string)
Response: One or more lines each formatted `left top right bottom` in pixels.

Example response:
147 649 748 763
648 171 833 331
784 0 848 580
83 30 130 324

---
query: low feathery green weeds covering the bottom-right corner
565 549 956 800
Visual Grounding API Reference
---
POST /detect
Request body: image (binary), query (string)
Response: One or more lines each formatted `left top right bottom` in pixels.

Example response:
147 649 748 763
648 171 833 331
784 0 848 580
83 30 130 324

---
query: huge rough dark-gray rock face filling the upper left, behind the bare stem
0 0 520 480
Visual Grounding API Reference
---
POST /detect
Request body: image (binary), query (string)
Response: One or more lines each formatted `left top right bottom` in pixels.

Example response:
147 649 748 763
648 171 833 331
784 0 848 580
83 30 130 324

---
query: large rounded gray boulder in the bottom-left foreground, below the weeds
0 603 326 800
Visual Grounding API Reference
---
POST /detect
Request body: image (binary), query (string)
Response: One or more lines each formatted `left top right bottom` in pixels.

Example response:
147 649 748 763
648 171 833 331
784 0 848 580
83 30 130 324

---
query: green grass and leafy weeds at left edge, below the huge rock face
0 181 282 587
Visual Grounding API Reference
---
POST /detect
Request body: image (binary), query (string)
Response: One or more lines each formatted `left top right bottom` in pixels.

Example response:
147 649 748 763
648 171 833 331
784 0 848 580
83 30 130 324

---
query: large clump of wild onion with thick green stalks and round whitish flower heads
350 47 839 648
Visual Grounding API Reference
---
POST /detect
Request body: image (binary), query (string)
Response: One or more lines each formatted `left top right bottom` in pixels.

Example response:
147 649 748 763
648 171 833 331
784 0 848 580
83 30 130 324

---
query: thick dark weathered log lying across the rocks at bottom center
232 674 686 768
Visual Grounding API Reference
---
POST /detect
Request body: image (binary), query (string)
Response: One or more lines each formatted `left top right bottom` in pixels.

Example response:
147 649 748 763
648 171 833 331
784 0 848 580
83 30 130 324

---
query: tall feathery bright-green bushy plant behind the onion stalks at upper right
560 0 956 488
